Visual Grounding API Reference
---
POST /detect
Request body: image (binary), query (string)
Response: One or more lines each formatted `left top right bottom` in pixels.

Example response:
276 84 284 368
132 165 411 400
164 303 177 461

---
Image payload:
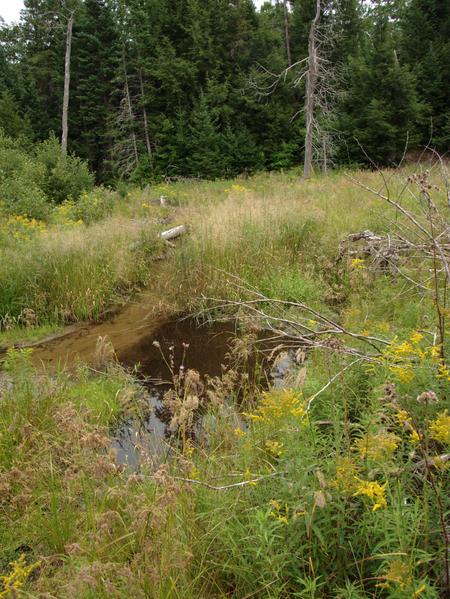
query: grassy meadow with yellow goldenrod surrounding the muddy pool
0 167 450 599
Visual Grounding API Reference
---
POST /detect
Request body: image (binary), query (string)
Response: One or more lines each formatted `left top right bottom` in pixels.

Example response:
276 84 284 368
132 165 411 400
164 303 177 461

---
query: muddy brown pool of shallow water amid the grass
33 290 289 470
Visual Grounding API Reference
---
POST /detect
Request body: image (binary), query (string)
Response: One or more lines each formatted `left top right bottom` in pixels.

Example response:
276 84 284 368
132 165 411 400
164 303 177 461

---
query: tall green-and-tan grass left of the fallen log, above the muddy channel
0 217 162 323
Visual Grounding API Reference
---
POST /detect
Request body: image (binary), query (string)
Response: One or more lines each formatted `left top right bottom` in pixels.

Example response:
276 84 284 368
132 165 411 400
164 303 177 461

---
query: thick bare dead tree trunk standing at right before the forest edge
303 0 320 179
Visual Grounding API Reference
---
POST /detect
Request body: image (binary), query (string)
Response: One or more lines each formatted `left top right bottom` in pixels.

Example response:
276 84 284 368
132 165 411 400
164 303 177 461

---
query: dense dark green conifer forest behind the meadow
0 0 450 183
